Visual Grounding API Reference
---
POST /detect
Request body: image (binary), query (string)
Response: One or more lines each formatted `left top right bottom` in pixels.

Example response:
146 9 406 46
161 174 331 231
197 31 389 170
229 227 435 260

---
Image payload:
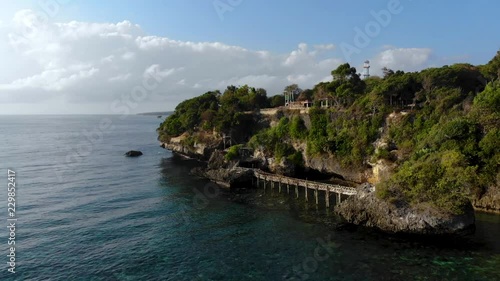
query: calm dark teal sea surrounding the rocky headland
0 116 500 281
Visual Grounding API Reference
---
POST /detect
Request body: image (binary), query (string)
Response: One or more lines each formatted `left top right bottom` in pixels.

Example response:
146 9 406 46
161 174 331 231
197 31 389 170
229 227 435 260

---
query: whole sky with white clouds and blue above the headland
0 0 500 114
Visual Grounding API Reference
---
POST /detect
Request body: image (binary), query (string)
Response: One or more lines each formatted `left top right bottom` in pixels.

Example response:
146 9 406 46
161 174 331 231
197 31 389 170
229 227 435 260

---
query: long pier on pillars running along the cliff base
254 170 357 208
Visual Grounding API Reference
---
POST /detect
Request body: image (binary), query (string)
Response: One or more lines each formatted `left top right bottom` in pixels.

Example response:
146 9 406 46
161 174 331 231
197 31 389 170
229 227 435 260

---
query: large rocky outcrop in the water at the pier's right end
335 184 475 235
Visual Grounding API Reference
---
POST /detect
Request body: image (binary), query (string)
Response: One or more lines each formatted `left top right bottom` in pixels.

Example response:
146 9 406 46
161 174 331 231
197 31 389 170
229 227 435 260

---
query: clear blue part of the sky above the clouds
67 0 500 63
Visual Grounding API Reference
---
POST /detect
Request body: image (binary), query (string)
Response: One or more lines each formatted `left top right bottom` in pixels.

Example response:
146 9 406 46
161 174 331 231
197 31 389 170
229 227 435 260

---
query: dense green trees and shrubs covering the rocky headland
158 51 500 214
